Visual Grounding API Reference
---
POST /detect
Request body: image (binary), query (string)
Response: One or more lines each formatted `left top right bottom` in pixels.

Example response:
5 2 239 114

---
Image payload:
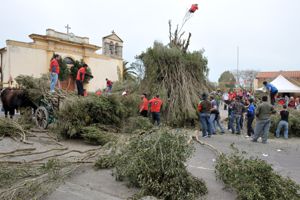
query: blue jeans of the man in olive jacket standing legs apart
253 119 271 143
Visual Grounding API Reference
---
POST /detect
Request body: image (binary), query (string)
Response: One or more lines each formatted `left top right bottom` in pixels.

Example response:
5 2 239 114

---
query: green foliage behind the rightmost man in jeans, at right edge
270 109 300 137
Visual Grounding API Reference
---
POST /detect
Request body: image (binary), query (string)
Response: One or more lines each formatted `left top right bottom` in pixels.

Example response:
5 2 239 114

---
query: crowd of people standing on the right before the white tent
198 81 300 143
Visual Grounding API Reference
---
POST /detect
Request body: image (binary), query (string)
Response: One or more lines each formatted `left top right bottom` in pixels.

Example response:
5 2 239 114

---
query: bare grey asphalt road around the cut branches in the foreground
46 133 300 200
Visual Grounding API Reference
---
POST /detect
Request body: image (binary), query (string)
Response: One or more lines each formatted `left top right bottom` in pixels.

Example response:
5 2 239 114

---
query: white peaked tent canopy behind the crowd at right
257 75 300 93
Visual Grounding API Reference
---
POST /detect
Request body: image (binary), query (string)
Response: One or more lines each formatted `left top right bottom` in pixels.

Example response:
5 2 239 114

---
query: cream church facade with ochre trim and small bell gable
0 29 123 92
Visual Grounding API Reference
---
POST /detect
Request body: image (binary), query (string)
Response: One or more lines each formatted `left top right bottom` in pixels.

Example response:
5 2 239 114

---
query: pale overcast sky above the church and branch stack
0 0 300 81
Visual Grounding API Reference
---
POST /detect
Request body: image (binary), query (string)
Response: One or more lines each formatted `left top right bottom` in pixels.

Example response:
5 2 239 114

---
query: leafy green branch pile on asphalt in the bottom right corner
216 148 300 200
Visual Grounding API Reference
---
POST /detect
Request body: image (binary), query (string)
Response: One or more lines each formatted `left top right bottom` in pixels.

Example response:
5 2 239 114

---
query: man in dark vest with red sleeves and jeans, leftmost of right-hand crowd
198 93 212 137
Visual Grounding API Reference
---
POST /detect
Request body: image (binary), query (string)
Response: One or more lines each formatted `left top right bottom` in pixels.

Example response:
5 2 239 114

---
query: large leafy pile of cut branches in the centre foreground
96 130 207 200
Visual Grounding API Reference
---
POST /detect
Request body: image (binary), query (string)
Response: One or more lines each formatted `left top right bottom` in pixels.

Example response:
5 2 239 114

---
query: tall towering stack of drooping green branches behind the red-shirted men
139 42 209 126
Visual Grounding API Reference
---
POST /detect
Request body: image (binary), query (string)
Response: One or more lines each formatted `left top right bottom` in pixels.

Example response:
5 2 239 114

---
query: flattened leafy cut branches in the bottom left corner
0 159 68 200
